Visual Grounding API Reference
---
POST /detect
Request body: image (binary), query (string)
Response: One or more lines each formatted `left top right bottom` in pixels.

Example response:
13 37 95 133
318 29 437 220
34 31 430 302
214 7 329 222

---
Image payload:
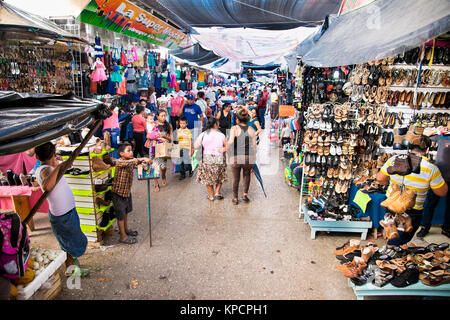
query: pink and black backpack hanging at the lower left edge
0 212 30 279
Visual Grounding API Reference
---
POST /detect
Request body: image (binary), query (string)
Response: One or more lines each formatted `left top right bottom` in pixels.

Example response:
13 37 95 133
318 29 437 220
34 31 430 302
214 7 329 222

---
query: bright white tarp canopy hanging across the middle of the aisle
191 27 318 64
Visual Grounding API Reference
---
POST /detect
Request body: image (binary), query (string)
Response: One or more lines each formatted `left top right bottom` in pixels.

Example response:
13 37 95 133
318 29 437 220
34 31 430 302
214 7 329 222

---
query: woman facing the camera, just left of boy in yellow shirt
148 109 173 192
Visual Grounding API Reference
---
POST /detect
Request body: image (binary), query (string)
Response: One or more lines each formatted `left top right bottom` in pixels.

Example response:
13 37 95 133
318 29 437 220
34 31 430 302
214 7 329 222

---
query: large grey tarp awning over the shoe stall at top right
296 0 450 67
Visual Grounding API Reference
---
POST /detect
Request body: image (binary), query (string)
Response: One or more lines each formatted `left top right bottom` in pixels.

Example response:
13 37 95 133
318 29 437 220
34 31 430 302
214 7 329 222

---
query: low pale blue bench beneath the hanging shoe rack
303 205 372 240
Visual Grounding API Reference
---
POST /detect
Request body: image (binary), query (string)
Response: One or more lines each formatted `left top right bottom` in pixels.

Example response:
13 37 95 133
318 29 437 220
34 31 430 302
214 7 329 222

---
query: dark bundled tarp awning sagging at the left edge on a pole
0 91 111 156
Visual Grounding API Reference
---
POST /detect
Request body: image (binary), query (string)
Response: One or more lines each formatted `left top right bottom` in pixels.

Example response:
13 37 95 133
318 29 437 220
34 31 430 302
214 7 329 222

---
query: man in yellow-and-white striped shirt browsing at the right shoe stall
377 135 448 246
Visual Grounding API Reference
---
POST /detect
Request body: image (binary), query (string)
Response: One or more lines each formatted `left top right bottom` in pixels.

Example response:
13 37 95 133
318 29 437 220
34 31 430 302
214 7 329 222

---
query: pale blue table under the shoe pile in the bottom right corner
348 279 450 300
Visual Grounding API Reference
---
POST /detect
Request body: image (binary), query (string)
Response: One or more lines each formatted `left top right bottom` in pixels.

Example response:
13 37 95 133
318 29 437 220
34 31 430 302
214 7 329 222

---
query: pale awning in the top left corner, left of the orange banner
0 1 88 44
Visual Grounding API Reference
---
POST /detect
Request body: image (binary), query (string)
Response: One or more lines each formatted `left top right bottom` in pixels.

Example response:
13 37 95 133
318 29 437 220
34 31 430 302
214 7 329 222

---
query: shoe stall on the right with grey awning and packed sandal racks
297 0 450 299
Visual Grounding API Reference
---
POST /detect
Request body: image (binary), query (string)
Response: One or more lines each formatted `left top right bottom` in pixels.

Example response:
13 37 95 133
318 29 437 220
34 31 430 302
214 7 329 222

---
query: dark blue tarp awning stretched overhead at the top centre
153 0 341 30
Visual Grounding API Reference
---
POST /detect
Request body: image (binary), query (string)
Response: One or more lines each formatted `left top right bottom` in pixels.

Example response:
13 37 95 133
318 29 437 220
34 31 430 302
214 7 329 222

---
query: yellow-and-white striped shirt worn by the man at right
381 156 445 210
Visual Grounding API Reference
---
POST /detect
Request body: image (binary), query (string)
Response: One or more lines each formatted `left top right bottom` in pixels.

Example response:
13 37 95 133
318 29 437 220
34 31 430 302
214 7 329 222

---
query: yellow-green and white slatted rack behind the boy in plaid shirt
58 149 115 246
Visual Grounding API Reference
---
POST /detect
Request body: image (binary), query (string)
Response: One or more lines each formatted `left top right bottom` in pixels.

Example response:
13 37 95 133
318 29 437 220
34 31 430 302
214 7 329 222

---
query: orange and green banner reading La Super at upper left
77 0 186 49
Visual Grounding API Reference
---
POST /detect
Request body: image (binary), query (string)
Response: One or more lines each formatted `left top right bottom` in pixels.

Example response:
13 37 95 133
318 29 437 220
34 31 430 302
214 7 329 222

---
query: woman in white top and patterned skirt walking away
194 118 227 201
